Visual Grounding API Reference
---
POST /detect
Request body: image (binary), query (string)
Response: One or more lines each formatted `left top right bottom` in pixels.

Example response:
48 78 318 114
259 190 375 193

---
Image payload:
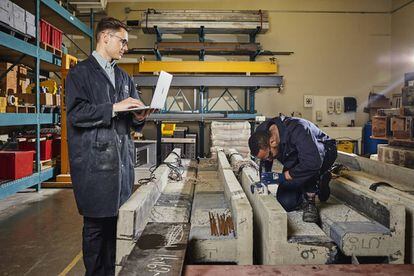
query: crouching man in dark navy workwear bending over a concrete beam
249 116 337 223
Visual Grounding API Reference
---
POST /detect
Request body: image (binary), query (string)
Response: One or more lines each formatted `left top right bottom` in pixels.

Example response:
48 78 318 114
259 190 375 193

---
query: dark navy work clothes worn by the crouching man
256 116 337 211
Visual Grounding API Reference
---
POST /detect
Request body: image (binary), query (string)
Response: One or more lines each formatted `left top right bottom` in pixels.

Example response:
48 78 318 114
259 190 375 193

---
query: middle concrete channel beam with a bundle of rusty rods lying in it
190 151 253 264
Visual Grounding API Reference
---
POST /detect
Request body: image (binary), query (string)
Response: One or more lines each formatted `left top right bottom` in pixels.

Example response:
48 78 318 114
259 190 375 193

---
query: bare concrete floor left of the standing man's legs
0 189 85 275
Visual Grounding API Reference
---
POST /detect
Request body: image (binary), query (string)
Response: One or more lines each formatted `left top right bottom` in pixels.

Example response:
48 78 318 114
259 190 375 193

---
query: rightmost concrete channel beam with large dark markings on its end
330 177 405 263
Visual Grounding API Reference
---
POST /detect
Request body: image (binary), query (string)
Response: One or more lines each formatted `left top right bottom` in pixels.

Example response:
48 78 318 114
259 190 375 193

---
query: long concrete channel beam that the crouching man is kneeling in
229 149 337 265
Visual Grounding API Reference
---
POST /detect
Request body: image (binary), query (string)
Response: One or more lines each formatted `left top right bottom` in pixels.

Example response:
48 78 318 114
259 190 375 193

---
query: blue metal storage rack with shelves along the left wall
0 0 93 199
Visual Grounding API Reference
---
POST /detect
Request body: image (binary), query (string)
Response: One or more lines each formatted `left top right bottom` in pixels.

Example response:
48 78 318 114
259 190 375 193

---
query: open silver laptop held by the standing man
118 71 172 112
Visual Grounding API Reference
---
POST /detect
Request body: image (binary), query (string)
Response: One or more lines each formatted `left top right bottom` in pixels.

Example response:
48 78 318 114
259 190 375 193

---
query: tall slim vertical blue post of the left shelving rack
35 0 41 191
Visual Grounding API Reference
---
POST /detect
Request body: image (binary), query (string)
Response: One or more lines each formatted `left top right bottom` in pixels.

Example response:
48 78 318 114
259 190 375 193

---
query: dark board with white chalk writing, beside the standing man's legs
119 222 190 276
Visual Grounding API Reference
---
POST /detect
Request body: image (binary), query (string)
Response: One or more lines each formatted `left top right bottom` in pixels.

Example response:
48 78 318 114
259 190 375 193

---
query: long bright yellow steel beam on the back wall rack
116 61 278 75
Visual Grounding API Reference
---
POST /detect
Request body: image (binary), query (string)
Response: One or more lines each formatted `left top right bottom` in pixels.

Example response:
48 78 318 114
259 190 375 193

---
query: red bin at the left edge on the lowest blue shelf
0 151 35 180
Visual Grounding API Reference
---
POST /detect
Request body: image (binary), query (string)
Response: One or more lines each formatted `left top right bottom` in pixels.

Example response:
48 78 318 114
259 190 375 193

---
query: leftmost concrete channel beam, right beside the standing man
116 149 191 270
